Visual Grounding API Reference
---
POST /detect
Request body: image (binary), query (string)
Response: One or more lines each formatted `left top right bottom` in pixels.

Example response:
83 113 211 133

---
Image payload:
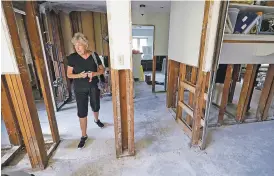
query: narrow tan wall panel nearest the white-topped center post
93 12 103 55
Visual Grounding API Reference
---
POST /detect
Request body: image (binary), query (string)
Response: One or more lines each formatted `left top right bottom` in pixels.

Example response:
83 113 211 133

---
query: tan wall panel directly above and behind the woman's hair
81 12 98 52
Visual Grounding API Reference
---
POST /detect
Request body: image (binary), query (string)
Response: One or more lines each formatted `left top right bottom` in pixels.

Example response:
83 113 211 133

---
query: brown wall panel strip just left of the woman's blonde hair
60 12 74 56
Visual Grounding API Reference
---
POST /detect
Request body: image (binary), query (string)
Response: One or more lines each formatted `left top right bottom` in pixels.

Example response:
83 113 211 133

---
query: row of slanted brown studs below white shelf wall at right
215 64 274 125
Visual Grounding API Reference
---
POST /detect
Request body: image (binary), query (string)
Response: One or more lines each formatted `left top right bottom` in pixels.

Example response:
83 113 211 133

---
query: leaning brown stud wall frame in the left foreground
1 1 60 169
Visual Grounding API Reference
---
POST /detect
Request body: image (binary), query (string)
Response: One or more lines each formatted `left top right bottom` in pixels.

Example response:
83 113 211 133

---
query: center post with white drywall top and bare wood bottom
107 1 135 157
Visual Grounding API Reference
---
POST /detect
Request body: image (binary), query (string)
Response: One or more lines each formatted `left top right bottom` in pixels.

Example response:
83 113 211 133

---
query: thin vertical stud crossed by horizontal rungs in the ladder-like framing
176 64 186 120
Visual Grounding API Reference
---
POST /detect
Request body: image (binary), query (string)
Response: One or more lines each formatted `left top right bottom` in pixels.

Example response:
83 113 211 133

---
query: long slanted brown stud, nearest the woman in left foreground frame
26 1 60 143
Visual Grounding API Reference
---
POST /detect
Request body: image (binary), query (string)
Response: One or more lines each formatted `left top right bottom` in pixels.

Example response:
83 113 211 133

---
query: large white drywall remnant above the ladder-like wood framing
168 1 205 67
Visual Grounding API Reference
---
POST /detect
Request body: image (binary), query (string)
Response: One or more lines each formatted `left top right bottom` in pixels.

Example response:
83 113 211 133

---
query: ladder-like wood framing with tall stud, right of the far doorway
167 1 221 148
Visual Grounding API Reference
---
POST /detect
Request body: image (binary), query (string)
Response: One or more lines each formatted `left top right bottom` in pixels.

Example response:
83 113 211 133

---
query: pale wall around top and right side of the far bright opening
132 12 169 56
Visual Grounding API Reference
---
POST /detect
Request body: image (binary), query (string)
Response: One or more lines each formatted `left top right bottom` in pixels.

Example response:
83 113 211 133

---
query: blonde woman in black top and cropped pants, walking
67 33 104 149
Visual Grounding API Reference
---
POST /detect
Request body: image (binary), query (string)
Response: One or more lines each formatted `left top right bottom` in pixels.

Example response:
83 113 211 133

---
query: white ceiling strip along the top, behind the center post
46 0 170 13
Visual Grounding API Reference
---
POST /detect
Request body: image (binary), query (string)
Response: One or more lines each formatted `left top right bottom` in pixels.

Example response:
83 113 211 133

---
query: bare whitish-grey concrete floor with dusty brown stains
3 83 274 176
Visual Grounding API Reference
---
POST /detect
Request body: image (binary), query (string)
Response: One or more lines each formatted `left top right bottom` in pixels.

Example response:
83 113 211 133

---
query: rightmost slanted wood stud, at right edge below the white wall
256 64 274 121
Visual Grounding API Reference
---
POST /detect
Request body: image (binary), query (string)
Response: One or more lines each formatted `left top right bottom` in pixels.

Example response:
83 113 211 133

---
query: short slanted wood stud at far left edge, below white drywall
1 75 23 146
